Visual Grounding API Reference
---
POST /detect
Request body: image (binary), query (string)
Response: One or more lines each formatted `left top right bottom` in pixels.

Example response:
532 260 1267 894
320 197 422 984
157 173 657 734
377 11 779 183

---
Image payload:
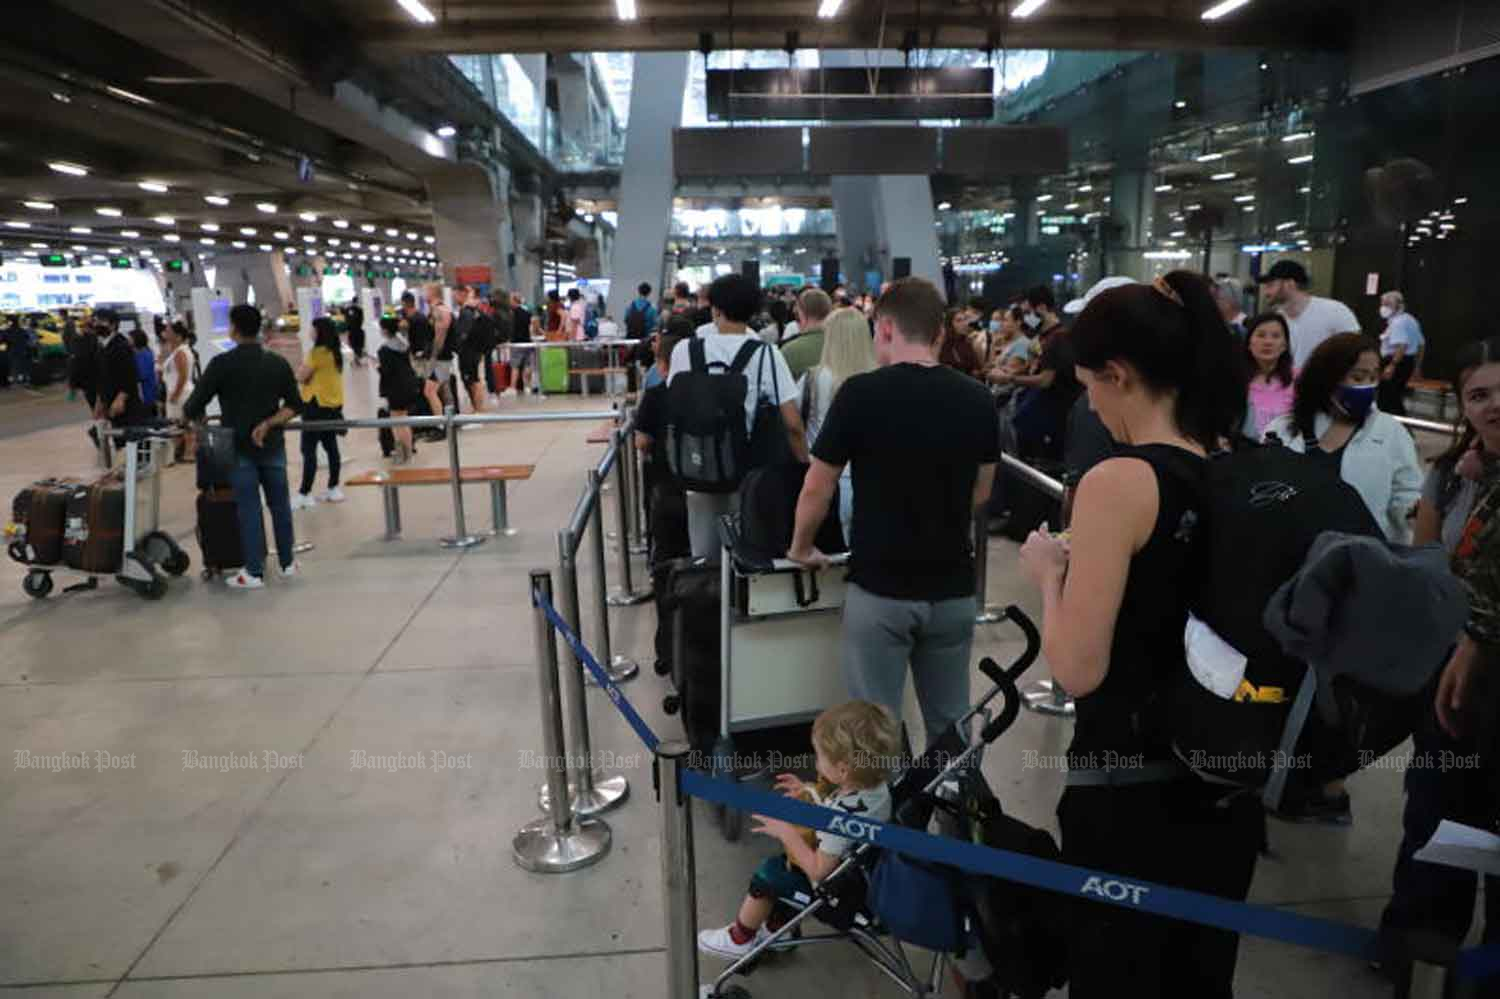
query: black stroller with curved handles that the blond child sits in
704 606 1067 999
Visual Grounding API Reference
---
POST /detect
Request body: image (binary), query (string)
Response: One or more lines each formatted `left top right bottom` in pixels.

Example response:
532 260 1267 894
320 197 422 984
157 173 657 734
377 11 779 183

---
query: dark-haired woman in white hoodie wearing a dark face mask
1266 333 1422 543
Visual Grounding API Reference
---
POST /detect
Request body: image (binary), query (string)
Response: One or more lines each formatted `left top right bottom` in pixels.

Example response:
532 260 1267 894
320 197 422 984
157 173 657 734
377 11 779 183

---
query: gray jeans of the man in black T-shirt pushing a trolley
843 584 977 743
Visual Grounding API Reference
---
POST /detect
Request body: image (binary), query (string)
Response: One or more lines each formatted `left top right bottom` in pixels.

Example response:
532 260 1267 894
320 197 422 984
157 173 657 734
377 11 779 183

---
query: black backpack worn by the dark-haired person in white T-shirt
666 336 765 492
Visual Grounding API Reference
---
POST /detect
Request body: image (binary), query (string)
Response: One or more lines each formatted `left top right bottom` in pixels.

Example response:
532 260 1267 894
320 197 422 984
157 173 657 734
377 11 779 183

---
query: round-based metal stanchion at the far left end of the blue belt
510 569 611 873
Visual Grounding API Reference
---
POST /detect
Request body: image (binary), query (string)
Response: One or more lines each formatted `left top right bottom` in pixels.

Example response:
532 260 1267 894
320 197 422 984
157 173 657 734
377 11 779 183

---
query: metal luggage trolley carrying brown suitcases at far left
9 426 192 600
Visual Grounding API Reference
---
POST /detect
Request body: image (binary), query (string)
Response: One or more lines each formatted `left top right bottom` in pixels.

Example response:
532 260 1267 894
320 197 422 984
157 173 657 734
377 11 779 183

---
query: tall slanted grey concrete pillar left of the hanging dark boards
609 53 687 315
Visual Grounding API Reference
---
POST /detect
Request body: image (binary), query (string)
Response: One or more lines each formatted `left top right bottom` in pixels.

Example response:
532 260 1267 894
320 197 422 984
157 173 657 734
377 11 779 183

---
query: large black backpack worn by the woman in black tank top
1164 444 1389 807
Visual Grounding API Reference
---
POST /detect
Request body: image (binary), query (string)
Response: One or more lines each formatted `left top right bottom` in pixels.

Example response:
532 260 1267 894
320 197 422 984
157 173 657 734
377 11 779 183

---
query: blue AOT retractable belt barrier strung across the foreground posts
531 591 1500 978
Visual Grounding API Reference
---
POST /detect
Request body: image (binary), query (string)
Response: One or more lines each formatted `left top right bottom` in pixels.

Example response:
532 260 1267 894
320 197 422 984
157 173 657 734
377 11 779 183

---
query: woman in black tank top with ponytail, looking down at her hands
1022 272 1265 999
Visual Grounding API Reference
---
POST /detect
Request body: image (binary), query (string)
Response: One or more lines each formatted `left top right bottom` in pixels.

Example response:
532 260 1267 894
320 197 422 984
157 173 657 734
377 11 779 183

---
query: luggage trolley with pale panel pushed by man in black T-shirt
711 516 849 842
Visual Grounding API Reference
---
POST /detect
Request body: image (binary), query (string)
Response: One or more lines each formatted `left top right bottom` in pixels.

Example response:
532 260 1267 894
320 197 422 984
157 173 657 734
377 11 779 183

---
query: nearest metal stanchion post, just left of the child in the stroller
656 740 699 999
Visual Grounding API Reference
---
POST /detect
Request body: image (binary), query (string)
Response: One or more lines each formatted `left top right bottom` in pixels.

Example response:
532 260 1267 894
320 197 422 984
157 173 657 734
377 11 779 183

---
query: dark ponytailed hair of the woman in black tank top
1067 270 1248 452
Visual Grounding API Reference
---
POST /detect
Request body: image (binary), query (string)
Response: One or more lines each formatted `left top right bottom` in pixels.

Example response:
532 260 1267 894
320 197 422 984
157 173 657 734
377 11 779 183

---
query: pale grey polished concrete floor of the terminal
0 361 1476 999
